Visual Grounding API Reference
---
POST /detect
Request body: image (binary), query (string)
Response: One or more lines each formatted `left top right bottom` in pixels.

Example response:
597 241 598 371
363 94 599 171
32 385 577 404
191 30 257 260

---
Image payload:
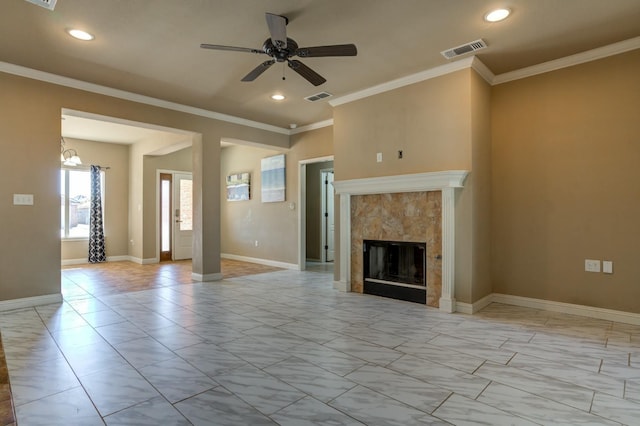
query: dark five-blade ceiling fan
200 13 358 86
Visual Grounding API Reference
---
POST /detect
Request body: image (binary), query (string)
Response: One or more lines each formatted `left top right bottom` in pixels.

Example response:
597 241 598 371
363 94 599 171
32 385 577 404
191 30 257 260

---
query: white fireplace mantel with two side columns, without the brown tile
333 170 469 312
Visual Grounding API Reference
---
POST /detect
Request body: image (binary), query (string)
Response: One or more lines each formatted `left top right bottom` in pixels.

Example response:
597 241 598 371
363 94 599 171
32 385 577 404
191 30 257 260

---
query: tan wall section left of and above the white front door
143 147 193 259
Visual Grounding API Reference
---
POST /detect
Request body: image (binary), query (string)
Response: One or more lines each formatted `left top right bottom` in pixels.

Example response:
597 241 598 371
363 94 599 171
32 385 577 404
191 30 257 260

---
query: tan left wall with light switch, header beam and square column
0 73 289 300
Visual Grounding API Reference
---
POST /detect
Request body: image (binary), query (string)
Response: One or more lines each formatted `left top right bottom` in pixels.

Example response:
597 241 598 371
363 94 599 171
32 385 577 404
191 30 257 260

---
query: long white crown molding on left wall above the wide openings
0 61 290 135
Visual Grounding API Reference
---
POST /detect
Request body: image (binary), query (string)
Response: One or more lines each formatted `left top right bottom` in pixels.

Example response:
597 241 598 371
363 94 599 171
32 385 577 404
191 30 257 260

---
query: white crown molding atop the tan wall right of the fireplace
492 37 640 86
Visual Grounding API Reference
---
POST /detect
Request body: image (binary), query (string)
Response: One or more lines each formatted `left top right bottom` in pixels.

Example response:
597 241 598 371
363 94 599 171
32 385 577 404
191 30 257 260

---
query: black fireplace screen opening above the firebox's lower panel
363 240 427 287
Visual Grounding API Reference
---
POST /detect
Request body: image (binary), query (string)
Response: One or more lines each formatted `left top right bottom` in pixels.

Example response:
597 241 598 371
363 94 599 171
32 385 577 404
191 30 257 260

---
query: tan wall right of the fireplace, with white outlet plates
491 50 640 313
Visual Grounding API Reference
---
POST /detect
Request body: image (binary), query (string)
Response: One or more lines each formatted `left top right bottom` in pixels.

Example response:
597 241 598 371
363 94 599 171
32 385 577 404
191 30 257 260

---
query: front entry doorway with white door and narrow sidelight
158 172 193 262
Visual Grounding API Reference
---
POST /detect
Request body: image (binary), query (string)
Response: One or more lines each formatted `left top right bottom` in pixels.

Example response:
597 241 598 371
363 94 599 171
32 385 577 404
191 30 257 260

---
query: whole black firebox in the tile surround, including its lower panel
363 240 427 304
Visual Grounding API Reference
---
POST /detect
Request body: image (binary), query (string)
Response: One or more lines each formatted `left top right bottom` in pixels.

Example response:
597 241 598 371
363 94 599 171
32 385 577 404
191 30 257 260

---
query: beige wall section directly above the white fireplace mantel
334 69 472 180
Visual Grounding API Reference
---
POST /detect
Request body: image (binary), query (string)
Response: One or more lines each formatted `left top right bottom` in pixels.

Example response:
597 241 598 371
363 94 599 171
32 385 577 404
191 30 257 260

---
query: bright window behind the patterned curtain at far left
60 169 104 238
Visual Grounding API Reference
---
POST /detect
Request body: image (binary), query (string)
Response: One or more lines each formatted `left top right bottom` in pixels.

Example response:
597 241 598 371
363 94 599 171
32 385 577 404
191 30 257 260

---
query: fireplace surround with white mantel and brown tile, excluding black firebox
333 170 469 312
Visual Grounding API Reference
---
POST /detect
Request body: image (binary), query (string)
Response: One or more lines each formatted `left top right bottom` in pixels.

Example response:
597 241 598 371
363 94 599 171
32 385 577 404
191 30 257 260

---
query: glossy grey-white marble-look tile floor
0 262 640 426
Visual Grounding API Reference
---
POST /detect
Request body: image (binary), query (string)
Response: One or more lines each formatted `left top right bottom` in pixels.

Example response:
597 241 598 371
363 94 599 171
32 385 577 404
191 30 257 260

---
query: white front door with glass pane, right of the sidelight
173 173 193 260
